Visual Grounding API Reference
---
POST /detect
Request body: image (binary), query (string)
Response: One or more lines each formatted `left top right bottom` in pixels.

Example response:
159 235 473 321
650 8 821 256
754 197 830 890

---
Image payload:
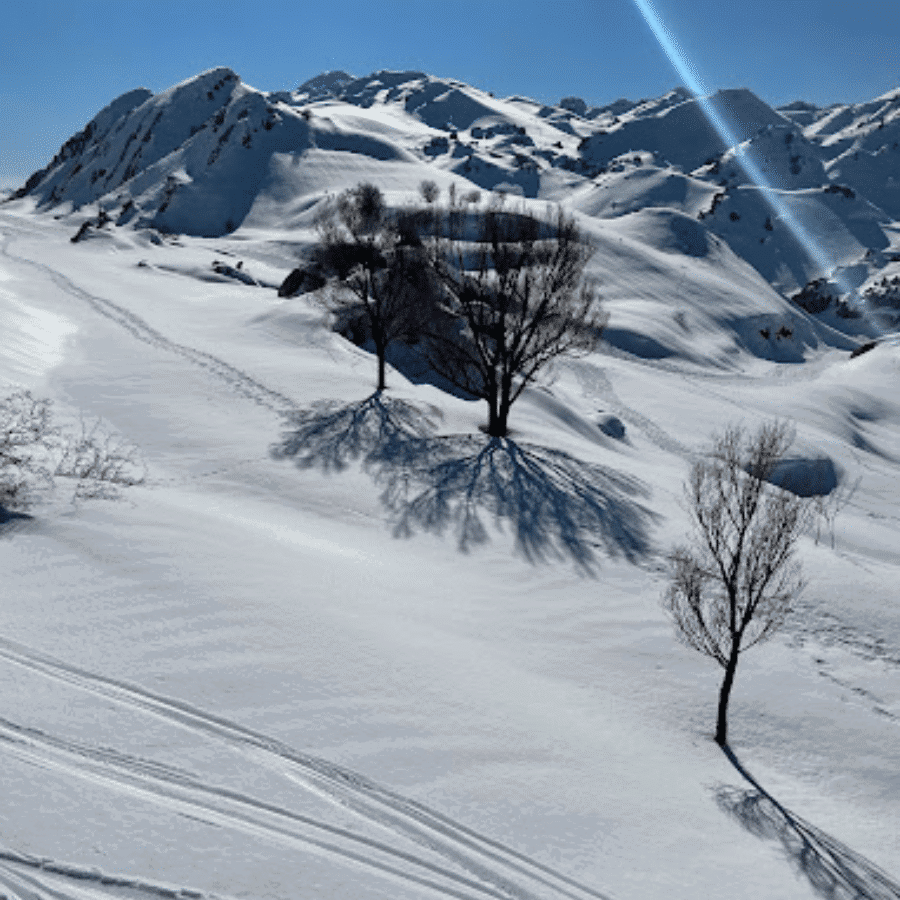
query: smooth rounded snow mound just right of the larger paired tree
579 208 834 367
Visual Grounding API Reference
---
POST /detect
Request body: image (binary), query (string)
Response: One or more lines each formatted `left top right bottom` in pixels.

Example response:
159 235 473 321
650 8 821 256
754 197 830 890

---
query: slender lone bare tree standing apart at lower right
663 422 809 747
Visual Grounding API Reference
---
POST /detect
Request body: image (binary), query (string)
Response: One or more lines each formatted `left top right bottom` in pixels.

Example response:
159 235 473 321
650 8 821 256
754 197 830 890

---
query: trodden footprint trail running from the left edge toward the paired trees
0 229 299 413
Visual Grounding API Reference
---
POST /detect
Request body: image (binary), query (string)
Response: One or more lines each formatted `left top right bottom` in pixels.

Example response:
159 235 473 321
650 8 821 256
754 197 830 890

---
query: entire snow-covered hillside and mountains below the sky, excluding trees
0 68 900 900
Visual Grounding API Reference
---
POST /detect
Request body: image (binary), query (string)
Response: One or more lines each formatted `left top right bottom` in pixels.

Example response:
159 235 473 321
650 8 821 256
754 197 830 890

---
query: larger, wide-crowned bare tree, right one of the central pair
427 197 607 437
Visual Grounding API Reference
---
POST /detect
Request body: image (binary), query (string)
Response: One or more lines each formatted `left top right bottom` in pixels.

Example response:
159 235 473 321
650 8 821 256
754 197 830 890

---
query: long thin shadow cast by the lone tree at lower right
716 747 900 900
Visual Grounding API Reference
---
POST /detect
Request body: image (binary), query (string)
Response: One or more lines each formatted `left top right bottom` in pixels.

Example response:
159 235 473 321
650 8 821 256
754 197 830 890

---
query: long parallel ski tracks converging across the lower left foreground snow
0 638 607 900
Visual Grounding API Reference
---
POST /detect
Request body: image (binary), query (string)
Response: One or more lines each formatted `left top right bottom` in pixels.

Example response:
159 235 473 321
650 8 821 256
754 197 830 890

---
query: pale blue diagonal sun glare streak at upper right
634 0 883 333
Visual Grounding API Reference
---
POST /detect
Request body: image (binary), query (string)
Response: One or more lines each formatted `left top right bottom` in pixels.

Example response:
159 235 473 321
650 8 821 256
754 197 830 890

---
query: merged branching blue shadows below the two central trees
272 393 653 574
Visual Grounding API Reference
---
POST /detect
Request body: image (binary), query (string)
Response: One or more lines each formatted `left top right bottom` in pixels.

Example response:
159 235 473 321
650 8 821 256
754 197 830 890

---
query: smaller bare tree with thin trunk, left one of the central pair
314 183 431 391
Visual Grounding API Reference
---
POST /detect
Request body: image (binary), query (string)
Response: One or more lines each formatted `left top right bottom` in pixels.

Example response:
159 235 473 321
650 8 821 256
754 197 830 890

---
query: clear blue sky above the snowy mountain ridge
0 0 900 186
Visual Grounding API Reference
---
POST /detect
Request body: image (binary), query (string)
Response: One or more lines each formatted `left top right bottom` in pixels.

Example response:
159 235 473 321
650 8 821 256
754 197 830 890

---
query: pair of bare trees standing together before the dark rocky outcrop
314 182 607 437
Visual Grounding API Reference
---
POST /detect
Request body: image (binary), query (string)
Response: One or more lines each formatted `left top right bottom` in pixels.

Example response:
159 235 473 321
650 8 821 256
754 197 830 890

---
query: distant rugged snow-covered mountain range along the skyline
11 68 900 332
